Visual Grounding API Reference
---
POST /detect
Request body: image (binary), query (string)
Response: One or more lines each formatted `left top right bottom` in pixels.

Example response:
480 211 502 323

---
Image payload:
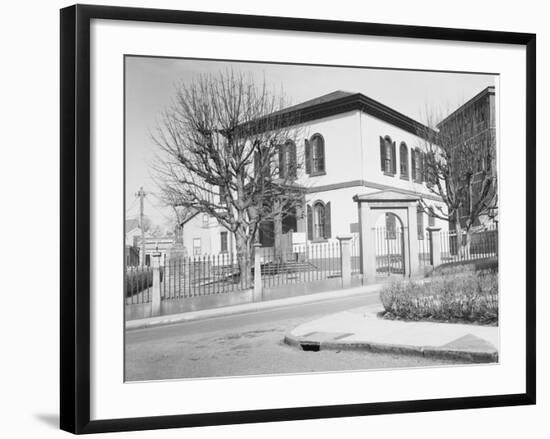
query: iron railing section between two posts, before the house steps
260 242 342 288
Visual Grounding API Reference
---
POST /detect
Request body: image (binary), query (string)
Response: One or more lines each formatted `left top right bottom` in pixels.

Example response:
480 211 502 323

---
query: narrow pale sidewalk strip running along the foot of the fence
125 283 383 330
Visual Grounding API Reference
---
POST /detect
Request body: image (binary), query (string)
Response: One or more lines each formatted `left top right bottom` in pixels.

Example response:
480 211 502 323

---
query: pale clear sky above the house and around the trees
125 56 498 226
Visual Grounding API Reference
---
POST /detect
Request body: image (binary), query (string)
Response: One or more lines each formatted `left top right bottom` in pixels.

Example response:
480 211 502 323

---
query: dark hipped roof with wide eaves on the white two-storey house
267 90 438 135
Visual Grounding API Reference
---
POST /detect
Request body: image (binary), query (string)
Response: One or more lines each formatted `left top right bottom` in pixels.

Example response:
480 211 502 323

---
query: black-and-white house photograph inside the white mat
126 54 501 382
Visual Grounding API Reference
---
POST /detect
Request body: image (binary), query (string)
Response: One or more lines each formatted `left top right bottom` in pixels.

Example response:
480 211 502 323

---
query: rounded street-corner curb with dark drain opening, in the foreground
283 333 498 363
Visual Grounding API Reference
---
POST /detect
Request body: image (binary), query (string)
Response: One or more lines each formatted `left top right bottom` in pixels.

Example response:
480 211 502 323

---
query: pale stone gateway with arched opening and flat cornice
353 190 420 282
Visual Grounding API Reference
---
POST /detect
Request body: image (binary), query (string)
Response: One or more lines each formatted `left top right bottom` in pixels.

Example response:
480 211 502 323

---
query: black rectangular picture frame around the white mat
60 5 536 433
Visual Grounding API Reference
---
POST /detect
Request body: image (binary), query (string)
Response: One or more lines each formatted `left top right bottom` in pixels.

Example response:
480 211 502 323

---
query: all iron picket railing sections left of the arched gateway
126 242 350 305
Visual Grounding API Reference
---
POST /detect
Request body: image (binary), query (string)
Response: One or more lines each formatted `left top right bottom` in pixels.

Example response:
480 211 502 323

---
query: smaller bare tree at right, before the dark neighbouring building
418 110 498 255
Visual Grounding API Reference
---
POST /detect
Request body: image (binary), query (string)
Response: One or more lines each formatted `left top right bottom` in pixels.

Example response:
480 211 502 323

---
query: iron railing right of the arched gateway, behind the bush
441 223 498 263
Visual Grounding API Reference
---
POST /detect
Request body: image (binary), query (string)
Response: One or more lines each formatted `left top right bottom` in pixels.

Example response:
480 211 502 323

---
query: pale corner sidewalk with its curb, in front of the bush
284 305 499 363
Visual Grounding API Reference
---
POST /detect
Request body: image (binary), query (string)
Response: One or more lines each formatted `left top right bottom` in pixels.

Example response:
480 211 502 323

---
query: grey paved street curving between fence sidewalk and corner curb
126 293 462 381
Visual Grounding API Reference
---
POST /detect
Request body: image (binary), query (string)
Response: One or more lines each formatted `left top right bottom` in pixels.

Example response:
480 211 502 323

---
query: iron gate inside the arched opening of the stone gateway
375 213 405 276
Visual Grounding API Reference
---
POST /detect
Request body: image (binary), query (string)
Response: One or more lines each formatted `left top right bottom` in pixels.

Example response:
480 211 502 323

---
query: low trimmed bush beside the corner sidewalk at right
380 267 498 325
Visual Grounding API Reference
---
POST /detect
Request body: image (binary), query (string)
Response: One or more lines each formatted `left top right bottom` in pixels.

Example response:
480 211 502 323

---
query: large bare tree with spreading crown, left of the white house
153 71 302 286
